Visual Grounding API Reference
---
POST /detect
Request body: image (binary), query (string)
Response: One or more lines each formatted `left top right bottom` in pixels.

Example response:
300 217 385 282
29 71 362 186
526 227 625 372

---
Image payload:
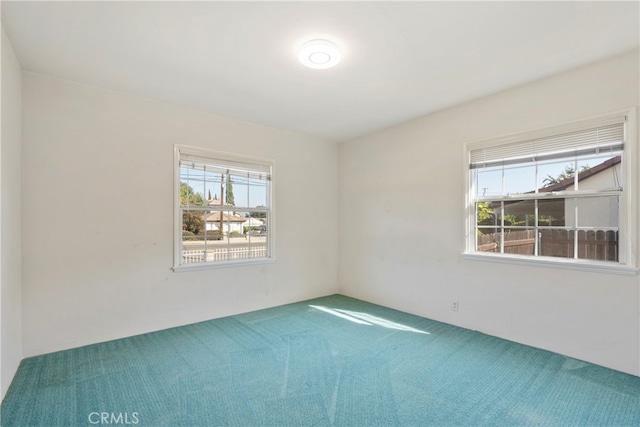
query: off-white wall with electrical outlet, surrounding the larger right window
339 51 640 375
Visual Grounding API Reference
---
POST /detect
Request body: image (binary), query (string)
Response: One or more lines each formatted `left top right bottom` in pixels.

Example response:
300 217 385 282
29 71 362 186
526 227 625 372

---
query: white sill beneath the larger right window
462 252 639 276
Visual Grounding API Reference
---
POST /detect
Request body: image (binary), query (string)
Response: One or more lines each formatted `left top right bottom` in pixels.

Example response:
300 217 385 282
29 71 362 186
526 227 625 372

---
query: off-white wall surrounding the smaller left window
22 73 338 356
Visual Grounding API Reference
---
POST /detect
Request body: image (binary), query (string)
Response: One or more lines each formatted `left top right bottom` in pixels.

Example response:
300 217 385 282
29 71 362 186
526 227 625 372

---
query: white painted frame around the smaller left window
173 144 276 272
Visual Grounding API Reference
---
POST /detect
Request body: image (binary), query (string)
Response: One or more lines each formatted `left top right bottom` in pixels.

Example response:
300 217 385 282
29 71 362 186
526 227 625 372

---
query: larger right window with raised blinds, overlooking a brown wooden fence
467 111 635 274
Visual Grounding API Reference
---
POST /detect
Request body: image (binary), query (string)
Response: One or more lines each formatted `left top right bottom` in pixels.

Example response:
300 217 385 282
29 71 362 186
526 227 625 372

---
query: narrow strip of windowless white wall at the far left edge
0 30 22 400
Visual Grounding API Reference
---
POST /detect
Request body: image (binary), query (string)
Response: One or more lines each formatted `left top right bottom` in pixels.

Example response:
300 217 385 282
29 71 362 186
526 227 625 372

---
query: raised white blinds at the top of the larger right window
469 116 626 169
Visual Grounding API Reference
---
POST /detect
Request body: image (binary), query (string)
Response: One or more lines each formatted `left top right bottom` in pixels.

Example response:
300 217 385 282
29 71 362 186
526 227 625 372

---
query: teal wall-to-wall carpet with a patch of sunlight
1 295 640 427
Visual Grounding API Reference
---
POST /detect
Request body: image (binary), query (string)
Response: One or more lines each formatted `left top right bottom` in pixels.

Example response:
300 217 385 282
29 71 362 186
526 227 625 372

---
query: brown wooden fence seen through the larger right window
477 229 618 261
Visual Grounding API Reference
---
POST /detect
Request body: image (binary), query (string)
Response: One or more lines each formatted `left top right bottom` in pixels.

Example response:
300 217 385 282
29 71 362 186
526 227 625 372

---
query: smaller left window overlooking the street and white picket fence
174 146 273 269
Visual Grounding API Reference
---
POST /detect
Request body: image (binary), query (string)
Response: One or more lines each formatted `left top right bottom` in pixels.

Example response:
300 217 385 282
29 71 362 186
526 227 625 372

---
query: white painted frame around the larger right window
463 107 640 275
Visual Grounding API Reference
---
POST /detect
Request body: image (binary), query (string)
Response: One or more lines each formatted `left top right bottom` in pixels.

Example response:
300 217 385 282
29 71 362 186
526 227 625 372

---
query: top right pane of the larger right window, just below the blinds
578 153 622 190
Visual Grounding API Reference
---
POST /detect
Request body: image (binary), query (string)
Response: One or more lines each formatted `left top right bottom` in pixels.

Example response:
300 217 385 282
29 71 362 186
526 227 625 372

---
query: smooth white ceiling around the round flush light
1 1 640 141
